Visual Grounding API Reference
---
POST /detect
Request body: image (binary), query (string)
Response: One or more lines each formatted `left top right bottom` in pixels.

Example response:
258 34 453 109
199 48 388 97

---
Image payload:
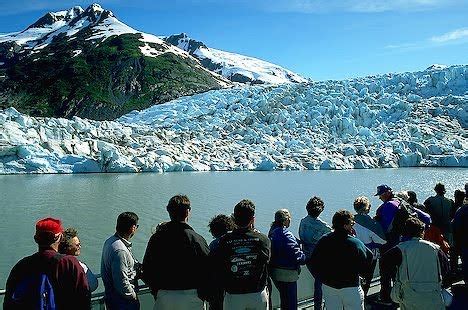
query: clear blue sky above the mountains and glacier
0 0 468 80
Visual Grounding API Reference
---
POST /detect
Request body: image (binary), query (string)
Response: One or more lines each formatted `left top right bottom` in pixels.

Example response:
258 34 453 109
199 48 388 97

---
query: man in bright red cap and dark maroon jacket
3 217 91 310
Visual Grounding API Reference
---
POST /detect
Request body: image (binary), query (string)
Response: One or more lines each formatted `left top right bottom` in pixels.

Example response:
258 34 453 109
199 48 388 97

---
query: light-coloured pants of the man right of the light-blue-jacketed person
322 284 364 310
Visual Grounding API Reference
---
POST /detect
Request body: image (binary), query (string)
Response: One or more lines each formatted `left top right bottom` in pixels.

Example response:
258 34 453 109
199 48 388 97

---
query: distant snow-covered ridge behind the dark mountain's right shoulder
164 33 307 84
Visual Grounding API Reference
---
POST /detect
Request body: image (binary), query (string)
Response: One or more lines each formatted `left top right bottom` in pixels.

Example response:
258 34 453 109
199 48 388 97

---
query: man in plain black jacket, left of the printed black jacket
143 195 209 310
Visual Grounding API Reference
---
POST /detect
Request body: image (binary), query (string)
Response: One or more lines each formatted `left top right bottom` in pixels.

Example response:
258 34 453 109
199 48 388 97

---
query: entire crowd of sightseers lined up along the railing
4 183 468 310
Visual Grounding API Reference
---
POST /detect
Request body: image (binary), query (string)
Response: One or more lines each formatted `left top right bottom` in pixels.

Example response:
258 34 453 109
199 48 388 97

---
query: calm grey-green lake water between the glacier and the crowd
0 168 468 291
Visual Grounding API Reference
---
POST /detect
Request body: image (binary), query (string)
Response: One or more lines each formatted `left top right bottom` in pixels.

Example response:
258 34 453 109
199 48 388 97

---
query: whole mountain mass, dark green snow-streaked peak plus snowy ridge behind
0 4 304 120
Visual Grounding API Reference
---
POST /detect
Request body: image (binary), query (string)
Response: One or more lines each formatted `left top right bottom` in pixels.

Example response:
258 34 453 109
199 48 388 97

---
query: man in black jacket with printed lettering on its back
210 200 270 310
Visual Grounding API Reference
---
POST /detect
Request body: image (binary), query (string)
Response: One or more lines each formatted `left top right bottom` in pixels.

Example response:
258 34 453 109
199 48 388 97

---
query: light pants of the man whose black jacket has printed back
224 288 268 310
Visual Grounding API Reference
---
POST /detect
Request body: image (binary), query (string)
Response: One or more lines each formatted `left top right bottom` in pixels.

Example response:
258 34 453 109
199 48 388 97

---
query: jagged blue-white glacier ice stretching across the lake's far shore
0 65 468 174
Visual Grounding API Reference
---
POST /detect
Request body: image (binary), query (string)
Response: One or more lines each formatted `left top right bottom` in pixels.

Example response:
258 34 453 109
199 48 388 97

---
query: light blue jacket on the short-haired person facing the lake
299 215 332 258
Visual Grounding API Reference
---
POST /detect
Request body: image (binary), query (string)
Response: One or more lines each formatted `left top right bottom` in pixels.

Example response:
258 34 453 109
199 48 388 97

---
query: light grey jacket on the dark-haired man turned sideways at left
101 234 137 299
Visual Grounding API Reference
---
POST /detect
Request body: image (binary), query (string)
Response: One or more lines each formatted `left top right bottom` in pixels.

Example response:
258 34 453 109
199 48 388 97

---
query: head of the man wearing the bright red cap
34 217 63 251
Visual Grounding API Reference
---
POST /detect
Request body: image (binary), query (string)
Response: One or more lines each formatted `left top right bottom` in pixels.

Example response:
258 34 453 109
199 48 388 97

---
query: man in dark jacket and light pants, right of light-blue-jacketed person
311 210 373 309
